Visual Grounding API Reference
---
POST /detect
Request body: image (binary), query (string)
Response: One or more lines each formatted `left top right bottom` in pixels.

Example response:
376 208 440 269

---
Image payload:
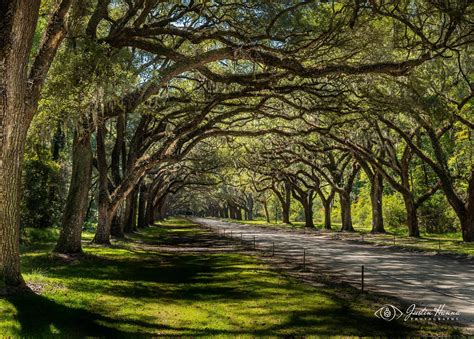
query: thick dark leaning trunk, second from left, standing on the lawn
54 127 93 254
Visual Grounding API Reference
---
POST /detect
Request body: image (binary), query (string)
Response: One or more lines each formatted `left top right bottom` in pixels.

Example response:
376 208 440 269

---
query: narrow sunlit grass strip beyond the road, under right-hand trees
224 219 474 256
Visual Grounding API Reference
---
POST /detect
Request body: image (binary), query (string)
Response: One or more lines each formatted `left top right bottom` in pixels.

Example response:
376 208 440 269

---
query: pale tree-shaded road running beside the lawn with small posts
192 218 474 332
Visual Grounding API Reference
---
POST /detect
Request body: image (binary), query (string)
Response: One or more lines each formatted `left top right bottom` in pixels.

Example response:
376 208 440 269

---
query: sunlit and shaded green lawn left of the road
0 220 456 337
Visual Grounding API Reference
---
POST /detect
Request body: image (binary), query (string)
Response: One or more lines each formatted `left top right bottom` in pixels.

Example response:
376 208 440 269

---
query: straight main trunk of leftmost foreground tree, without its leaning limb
0 0 39 289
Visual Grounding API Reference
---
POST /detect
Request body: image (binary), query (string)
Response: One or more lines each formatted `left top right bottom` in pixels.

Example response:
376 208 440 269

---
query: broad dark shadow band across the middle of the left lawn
25 248 266 301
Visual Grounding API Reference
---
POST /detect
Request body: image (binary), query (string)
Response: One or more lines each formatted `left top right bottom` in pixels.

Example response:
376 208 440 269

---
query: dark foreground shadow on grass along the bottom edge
7 293 412 338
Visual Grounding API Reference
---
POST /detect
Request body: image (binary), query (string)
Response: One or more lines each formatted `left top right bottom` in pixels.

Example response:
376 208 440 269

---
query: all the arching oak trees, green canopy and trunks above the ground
0 0 474 292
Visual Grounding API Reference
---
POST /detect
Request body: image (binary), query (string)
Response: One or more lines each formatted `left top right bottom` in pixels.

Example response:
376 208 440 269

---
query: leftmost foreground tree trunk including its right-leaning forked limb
0 0 72 288
